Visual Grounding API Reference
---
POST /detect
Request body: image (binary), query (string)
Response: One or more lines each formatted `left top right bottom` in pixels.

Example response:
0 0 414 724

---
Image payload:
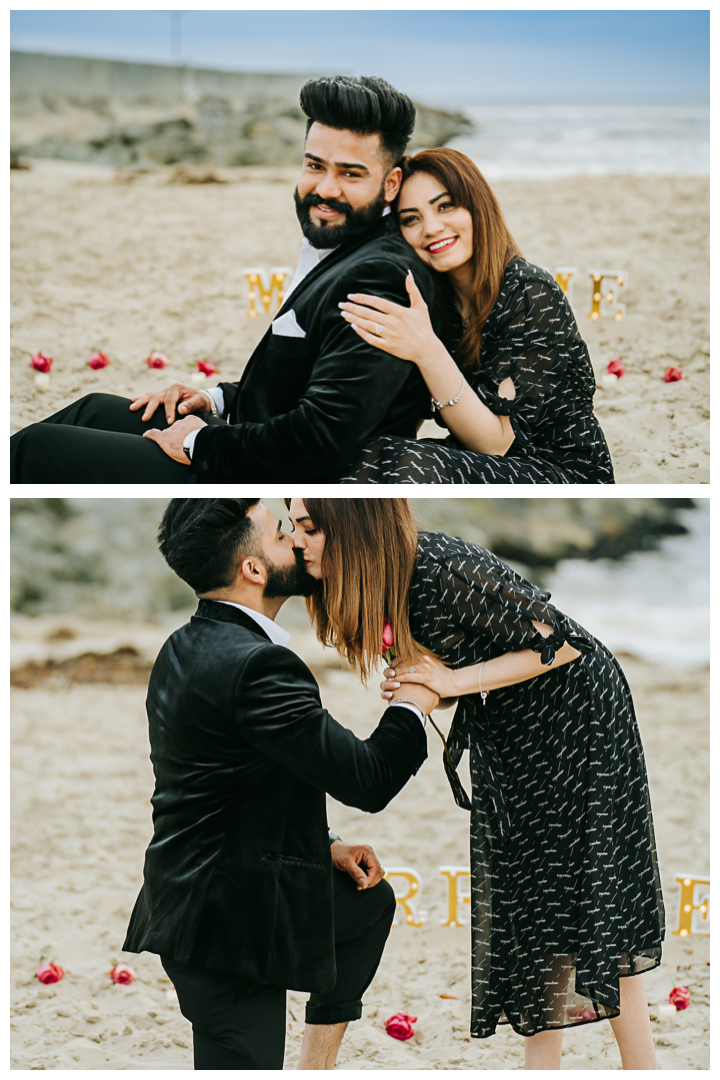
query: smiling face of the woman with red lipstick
397 173 473 273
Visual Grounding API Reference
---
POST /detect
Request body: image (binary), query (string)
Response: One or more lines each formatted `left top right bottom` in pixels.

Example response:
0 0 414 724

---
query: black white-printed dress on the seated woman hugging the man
341 258 614 484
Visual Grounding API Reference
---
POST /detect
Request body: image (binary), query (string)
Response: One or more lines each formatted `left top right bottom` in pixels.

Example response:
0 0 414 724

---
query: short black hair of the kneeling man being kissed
158 499 260 595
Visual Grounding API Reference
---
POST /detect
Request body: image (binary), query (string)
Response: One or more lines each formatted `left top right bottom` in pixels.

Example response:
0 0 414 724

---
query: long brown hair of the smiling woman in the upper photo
393 147 520 368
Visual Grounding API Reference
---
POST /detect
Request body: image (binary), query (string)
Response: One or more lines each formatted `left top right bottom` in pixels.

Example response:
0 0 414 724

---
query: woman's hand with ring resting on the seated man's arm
339 270 446 368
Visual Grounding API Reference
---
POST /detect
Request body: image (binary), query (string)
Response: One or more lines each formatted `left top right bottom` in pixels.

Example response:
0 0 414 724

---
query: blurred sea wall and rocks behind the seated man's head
11 53 472 167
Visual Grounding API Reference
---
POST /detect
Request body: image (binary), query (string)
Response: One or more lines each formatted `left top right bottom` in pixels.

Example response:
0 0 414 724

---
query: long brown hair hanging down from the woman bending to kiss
285 499 434 681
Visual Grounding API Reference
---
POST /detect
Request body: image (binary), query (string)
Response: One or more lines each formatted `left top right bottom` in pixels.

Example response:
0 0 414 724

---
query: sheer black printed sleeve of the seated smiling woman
473 268 587 443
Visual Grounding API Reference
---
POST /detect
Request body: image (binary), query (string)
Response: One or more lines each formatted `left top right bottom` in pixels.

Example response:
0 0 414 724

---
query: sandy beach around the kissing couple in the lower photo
11 613 709 1070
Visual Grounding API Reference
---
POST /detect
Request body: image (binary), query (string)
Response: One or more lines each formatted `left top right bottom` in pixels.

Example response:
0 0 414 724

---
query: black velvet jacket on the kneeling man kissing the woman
123 600 426 993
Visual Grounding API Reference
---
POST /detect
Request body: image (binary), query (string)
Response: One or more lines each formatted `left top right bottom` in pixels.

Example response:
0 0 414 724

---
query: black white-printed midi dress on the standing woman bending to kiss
409 534 664 1038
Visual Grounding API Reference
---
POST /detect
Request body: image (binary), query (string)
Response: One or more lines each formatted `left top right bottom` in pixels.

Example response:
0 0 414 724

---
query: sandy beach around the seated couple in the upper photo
11 160 709 484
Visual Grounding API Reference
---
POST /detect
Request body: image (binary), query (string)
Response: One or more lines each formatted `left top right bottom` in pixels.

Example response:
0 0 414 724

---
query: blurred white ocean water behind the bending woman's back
543 499 710 667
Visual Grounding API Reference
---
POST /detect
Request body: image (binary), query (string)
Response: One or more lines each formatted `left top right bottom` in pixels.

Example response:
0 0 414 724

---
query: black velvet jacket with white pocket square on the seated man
192 215 439 483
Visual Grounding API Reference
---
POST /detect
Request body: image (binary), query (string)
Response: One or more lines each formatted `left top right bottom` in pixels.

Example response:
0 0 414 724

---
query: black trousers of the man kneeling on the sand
161 870 395 1069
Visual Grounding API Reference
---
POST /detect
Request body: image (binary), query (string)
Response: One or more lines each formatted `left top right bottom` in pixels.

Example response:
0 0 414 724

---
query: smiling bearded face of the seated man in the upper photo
295 123 402 247
